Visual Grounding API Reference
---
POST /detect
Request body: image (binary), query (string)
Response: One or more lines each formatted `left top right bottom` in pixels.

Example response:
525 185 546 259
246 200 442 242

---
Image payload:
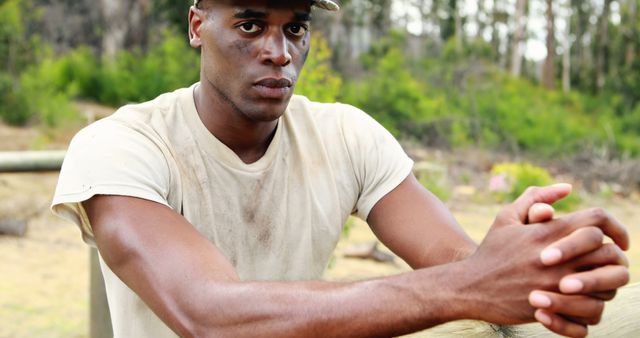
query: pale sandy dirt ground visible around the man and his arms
0 117 640 338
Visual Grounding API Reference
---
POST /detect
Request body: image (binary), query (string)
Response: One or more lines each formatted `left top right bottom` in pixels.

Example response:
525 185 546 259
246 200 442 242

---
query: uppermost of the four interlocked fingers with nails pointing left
540 227 604 265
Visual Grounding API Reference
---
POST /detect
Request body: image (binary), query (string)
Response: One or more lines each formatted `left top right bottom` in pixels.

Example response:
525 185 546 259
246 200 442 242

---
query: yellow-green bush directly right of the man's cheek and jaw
296 34 342 102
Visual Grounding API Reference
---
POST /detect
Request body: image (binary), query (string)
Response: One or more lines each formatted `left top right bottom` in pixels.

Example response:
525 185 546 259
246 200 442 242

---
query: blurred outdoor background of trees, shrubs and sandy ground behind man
0 0 640 338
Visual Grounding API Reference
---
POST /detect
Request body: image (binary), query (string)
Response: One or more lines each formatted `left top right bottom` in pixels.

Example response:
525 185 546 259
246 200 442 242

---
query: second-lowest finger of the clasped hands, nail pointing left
529 290 604 325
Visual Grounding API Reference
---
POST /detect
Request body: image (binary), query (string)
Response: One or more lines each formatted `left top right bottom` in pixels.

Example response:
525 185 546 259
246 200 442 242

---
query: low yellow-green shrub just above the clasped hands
490 163 580 210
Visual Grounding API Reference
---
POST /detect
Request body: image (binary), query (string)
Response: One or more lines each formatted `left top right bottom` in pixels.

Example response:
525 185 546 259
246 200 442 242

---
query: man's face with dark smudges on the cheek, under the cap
190 0 310 122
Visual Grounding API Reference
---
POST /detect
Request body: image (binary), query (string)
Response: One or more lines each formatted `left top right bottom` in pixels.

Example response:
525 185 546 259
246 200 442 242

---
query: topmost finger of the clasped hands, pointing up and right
511 183 572 223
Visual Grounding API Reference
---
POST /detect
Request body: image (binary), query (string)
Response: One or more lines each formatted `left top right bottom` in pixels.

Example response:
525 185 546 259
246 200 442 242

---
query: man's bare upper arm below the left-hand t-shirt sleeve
83 195 238 332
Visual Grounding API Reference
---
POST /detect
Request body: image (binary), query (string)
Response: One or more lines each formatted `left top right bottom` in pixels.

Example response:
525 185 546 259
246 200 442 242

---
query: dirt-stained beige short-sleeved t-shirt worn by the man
52 85 413 338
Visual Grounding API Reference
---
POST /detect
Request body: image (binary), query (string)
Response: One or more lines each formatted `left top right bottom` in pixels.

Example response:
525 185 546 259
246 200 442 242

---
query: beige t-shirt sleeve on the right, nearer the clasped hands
342 105 413 220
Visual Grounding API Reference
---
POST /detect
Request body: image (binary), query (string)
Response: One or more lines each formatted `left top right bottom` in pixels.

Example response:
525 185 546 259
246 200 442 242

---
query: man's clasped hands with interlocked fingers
471 184 629 337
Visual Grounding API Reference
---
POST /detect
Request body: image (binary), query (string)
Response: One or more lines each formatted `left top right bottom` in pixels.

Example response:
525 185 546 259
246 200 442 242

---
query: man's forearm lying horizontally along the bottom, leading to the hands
172 264 475 337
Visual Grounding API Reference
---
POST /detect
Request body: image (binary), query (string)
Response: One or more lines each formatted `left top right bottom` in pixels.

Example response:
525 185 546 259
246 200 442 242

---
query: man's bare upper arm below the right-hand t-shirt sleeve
367 174 476 268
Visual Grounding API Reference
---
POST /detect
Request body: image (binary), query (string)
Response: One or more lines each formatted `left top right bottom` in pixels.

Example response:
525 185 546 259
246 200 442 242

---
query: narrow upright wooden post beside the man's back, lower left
89 248 113 338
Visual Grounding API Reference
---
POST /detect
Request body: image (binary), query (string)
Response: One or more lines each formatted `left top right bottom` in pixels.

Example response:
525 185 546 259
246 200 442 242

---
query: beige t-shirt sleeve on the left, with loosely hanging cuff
51 120 170 245
